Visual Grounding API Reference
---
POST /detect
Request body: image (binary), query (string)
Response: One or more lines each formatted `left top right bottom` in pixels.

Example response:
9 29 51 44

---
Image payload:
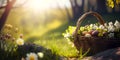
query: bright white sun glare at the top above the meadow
21 0 70 12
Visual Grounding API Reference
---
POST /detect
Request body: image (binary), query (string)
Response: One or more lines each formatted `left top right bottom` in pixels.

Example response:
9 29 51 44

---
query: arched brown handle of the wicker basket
73 11 104 35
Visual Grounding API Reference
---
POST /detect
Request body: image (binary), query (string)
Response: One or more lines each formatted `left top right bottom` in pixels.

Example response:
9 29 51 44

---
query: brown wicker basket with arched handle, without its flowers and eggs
73 11 120 55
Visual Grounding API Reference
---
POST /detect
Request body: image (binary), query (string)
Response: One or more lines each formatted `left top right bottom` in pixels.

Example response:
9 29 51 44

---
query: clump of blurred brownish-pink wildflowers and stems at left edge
0 24 19 60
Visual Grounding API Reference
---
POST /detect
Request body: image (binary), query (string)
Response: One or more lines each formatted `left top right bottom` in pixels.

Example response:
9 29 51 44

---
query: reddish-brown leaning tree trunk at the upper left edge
0 0 16 31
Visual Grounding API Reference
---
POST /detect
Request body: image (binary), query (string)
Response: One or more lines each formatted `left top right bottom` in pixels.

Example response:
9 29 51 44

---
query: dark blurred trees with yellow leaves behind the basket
66 0 120 21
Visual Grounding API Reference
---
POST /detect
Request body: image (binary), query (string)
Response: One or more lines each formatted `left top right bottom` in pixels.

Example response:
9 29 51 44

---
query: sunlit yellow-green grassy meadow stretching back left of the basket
2 9 77 57
